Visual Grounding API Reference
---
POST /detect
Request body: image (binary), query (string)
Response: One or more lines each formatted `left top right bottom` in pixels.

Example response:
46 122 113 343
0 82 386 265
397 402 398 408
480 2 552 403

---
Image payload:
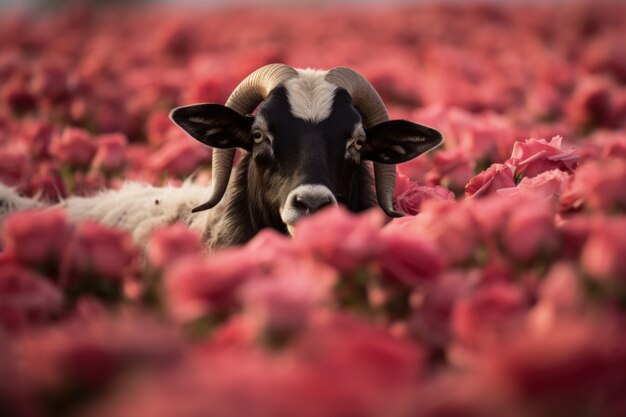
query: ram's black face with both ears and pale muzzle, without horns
170 79 443 231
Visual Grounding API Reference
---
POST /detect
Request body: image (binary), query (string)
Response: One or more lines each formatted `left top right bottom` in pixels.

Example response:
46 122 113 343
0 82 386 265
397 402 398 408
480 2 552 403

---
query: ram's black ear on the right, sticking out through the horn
361 120 443 164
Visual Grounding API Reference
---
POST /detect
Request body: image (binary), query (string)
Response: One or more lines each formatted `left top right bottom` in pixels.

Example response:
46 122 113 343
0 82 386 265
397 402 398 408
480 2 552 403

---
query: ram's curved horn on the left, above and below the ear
191 64 298 213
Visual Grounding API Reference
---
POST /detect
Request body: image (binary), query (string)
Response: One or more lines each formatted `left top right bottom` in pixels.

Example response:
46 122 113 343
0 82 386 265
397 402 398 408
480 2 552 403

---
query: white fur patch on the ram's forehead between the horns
285 69 337 123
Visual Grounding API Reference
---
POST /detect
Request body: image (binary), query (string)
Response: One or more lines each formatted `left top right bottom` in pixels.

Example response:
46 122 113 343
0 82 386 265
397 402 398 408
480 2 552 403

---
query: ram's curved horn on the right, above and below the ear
326 67 402 217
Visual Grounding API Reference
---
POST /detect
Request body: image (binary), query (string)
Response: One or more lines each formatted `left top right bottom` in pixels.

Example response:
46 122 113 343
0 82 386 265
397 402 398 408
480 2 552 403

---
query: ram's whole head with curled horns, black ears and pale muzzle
171 64 443 236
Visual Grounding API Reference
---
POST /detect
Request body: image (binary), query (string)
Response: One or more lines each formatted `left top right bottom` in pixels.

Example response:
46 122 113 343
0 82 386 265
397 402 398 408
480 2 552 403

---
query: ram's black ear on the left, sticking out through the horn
170 104 254 151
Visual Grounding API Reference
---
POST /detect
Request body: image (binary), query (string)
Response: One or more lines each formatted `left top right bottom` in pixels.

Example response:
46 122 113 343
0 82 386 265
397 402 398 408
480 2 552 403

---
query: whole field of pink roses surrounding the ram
0 2 626 417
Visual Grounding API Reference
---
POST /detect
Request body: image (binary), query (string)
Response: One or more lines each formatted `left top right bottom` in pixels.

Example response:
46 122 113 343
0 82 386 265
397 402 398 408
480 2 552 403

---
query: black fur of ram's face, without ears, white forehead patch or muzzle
249 87 365 218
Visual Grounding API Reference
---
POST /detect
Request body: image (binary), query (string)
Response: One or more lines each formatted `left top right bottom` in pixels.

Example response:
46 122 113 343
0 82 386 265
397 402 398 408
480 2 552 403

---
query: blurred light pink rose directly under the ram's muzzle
295 207 383 272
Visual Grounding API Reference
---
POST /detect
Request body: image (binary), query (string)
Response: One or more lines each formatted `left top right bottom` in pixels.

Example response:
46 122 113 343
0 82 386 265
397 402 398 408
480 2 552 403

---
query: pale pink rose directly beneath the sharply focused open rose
497 169 570 200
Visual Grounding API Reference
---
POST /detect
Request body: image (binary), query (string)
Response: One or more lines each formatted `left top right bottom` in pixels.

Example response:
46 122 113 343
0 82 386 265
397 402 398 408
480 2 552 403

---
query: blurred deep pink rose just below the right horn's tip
377 229 444 287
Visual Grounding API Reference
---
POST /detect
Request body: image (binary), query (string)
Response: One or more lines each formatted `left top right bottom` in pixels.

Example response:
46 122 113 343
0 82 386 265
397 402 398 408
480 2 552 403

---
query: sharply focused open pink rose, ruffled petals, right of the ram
509 136 579 177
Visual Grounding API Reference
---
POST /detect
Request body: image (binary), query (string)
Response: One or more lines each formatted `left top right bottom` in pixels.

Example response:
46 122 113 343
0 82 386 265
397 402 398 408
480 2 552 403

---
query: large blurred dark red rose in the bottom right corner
480 314 626 408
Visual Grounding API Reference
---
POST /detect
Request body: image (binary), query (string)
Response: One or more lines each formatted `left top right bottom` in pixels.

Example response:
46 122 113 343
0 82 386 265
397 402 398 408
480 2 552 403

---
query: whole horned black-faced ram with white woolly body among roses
0 64 443 248
